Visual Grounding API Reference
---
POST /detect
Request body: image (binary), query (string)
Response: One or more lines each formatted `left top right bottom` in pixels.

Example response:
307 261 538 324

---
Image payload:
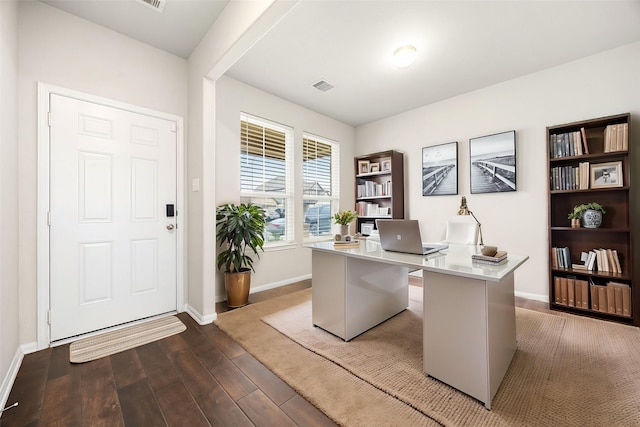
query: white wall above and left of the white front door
18 1 187 343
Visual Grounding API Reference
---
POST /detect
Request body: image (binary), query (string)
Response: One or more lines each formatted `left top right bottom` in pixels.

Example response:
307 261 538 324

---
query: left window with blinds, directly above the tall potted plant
240 114 294 246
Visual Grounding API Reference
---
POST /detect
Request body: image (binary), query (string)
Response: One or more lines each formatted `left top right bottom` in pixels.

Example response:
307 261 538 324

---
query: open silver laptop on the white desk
376 219 449 255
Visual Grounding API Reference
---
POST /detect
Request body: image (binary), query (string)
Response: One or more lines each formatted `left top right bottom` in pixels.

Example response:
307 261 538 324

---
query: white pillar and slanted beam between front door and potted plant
187 0 297 323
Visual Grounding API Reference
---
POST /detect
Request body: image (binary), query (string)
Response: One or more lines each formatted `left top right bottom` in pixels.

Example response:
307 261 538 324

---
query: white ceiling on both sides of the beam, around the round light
41 0 640 126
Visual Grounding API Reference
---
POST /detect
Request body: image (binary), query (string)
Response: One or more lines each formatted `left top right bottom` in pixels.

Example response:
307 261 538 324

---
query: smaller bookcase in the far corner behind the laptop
354 150 404 232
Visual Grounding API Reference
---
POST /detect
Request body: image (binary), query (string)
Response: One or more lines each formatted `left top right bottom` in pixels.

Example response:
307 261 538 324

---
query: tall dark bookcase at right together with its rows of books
547 113 640 326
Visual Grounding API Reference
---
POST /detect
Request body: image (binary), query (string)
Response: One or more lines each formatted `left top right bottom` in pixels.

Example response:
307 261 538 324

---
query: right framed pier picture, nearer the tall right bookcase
469 130 516 194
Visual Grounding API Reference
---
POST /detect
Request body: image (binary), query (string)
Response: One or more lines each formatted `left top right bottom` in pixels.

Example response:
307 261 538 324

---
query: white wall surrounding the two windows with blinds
215 77 355 300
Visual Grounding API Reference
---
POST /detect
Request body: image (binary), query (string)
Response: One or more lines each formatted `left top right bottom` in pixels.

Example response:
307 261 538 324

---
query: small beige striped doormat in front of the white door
69 316 187 363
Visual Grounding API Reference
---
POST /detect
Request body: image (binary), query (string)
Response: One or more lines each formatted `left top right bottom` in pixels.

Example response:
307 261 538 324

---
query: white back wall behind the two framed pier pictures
356 42 640 300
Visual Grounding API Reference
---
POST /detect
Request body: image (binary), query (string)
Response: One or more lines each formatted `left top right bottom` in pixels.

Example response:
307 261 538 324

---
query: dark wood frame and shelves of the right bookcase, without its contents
547 113 640 326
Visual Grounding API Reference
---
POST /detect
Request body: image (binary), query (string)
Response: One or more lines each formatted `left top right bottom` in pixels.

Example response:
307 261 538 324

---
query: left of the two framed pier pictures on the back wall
422 142 458 196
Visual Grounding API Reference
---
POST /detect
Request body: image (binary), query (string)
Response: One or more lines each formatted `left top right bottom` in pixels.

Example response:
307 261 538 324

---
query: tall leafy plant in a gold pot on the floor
216 203 266 308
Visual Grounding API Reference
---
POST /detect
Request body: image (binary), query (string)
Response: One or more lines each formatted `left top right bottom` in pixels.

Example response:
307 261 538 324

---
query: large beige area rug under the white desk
216 286 640 426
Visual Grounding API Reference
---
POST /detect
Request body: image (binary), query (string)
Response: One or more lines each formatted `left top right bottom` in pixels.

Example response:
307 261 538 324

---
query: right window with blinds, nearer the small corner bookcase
302 134 340 237
